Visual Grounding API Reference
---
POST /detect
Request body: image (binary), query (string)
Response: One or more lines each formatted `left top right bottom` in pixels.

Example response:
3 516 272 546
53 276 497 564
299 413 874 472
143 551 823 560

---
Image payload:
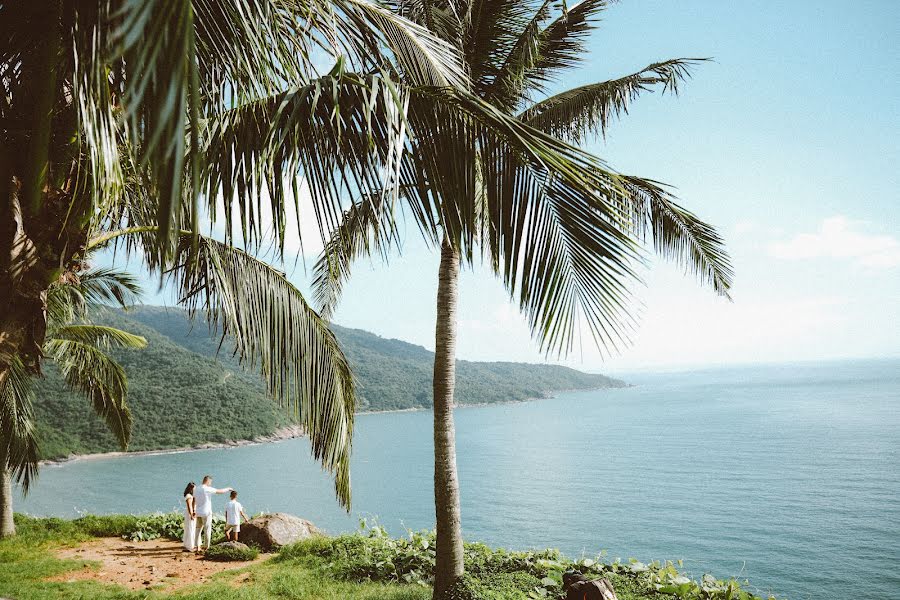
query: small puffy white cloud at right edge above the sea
769 216 900 268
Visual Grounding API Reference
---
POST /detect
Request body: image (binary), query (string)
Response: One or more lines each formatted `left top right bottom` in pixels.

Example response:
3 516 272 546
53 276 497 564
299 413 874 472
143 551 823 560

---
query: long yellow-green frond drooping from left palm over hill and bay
168 236 356 510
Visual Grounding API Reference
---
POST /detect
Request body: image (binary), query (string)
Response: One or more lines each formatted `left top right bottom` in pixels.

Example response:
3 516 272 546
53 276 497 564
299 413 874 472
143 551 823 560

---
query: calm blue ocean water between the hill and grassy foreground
17 360 900 600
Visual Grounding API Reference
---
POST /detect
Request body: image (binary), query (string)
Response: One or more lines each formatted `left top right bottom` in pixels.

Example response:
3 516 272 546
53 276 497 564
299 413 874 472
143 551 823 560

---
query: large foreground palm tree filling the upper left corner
0 0 624 536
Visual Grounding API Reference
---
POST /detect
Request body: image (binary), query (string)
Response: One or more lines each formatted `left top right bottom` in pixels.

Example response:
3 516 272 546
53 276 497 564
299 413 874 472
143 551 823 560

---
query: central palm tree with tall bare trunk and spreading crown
314 0 732 598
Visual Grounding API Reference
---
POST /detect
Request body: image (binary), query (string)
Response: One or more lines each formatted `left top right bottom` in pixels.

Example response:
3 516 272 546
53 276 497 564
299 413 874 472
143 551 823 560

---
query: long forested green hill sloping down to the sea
35 306 625 458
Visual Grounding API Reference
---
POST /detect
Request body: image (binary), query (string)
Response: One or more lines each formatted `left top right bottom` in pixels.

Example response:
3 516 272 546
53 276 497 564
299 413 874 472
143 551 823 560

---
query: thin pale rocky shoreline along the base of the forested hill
38 384 633 468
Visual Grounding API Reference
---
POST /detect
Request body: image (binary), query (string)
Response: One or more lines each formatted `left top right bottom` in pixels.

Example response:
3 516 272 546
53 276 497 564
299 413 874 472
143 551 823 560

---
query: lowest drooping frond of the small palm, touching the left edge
0 358 39 494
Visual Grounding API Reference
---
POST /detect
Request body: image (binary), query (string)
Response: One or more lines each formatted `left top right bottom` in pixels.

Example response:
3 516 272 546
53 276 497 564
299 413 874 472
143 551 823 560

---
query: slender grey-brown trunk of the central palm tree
433 238 463 599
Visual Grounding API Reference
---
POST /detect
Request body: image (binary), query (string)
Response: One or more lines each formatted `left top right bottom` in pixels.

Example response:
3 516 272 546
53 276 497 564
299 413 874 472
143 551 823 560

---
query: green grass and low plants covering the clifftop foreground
0 515 772 600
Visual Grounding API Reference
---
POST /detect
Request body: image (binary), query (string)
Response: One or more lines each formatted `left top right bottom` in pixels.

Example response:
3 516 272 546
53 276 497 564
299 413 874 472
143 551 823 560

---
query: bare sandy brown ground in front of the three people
51 538 266 590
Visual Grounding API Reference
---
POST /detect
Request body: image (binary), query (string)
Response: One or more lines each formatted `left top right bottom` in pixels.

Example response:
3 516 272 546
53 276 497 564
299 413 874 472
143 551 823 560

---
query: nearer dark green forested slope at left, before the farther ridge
34 310 290 458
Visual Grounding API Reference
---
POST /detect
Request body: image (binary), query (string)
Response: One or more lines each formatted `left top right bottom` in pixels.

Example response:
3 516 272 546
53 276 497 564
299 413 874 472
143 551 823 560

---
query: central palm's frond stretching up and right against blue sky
519 58 708 144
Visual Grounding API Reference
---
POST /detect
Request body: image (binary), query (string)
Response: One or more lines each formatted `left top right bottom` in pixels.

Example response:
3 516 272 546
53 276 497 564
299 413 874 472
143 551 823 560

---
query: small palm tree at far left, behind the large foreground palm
0 266 147 537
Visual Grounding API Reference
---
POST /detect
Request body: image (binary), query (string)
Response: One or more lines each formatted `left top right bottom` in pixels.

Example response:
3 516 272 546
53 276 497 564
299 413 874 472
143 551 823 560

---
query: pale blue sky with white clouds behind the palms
107 0 900 373
